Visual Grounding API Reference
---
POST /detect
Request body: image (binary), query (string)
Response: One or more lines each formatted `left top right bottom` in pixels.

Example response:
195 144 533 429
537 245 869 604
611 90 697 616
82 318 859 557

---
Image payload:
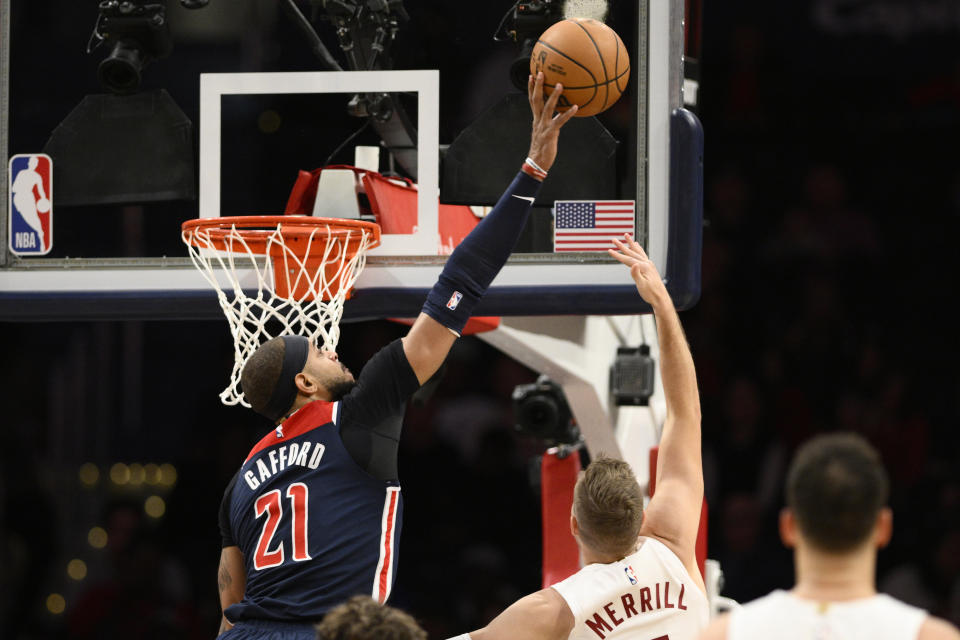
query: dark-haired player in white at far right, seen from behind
702 433 960 640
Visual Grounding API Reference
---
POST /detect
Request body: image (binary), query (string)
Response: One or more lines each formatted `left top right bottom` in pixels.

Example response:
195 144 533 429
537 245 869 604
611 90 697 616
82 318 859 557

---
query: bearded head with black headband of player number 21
240 336 356 421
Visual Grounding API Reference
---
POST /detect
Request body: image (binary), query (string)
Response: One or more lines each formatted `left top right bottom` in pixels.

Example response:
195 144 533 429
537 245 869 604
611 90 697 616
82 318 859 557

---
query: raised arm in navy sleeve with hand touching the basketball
403 73 577 384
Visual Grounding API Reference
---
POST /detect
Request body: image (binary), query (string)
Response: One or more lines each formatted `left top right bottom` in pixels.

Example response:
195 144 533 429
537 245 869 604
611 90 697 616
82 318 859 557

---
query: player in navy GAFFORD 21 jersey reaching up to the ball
218 74 576 640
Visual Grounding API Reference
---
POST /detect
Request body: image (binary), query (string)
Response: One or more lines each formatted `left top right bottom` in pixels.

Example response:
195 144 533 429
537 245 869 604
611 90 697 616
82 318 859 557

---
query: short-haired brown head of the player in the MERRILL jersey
573 455 643 558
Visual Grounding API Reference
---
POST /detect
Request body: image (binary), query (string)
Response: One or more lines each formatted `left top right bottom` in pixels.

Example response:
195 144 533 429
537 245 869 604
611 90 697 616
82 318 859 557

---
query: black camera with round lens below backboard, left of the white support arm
513 376 580 446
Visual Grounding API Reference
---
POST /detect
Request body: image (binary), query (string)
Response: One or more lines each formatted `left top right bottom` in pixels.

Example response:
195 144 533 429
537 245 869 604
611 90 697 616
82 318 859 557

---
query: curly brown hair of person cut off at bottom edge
316 596 427 640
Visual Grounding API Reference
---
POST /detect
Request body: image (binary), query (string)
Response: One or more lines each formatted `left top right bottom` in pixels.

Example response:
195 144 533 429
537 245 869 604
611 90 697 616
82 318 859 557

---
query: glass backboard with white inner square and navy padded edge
0 0 702 320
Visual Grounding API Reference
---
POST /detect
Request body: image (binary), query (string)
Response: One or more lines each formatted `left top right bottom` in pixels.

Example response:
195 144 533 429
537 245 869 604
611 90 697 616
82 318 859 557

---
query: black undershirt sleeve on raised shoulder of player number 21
338 340 420 480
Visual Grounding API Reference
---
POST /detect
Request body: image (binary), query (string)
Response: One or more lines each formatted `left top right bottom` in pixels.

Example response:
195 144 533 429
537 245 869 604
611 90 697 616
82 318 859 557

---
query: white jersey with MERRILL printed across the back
552 538 710 640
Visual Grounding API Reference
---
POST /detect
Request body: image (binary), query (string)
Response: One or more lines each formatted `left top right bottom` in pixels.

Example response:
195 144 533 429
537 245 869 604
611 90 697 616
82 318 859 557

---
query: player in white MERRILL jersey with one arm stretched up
453 236 709 640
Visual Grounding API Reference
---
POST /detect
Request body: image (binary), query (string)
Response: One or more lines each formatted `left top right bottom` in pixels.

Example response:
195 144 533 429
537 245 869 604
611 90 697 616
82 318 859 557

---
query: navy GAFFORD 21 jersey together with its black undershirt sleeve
221 341 419 623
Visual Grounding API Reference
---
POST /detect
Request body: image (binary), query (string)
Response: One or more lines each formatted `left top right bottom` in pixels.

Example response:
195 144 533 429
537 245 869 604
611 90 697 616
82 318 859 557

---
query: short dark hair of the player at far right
786 433 890 553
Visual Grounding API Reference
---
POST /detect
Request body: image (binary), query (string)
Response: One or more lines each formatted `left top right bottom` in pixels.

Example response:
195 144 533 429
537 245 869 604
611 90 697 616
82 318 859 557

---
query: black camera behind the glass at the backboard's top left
87 0 209 94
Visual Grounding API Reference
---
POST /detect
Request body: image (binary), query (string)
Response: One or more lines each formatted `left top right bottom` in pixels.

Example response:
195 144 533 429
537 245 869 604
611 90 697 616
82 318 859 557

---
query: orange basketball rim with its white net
182 218 379 407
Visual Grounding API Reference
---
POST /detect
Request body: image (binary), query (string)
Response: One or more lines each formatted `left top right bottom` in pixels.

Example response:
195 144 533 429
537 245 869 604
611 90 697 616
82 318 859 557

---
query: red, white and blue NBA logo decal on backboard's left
7 153 53 256
